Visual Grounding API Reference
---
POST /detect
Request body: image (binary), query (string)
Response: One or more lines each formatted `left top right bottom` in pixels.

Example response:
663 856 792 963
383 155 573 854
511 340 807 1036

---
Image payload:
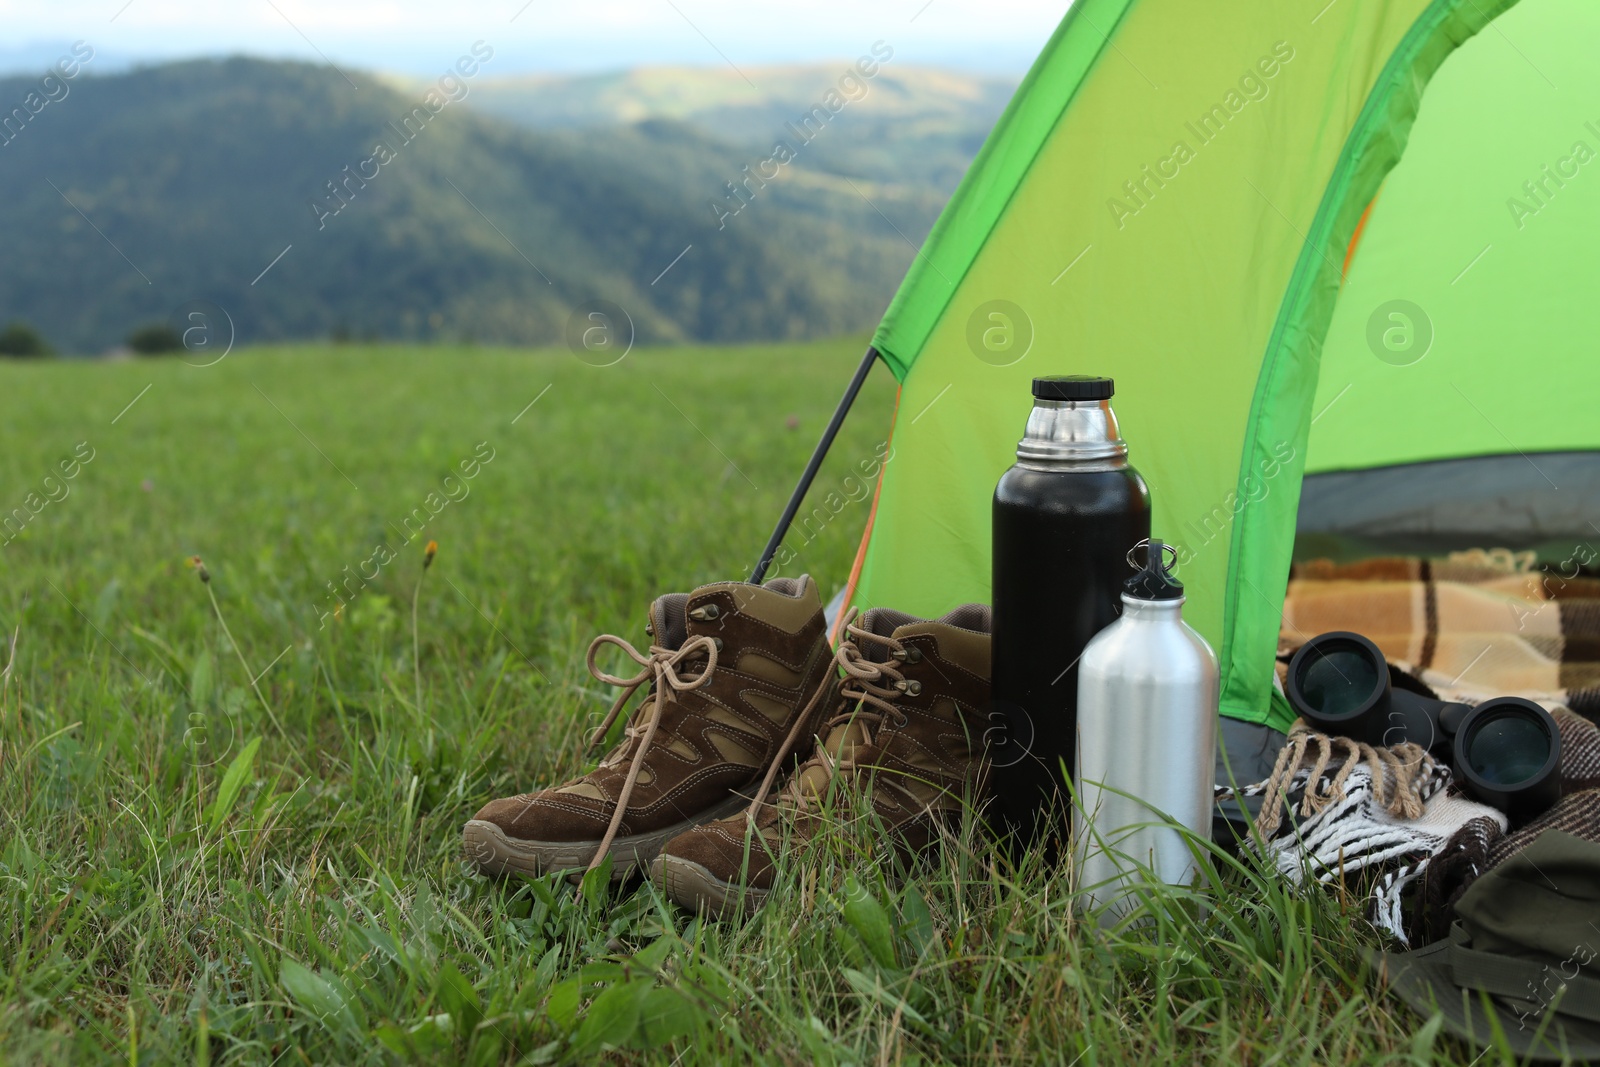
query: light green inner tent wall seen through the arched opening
1306 0 1600 476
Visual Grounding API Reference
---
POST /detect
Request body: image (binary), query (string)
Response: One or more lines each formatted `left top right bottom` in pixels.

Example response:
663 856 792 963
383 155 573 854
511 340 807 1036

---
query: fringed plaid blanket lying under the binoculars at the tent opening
1262 545 1600 944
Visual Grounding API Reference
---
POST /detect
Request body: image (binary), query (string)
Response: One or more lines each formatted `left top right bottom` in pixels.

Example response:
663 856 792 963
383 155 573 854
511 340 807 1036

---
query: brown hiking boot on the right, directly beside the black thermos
650 605 992 915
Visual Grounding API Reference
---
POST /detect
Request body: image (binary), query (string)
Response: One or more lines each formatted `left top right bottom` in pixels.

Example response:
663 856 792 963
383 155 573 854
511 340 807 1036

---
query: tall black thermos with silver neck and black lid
990 374 1150 854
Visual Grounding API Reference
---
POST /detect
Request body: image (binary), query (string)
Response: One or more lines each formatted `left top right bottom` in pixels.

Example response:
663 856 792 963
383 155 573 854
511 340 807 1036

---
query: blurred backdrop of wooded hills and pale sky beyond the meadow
0 0 1061 355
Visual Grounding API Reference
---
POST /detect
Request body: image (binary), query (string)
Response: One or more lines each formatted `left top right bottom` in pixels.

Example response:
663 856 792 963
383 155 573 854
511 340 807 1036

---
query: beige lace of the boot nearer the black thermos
746 608 910 824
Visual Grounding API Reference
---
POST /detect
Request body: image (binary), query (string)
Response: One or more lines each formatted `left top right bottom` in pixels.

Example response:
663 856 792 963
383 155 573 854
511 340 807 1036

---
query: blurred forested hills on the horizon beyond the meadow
0 59 1000 352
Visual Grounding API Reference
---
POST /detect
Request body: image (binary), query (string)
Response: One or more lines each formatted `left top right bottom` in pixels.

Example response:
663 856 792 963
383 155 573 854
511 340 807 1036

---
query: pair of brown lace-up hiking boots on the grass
462 576 990 915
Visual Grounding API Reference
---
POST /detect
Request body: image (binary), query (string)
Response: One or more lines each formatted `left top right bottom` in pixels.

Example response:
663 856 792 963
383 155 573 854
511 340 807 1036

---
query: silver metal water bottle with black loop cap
1074 539 1218 918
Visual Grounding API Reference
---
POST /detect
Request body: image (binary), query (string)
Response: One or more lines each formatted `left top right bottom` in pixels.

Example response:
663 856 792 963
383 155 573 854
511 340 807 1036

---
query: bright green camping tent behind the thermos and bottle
771 0 1600 728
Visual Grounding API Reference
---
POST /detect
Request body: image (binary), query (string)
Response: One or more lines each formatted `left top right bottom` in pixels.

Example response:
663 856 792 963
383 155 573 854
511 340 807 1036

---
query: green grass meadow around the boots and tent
0 341 1509 1064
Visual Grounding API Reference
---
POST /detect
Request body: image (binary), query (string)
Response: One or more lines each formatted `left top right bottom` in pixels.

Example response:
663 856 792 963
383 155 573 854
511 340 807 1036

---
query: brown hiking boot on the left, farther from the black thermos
462 576 835 880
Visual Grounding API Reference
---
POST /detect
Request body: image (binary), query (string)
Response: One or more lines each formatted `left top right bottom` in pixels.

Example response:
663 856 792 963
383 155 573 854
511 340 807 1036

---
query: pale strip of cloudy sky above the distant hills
0 0 1066 77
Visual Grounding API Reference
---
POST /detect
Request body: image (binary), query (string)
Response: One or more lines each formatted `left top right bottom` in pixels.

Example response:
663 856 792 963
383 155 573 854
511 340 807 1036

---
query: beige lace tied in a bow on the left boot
587 633 717 870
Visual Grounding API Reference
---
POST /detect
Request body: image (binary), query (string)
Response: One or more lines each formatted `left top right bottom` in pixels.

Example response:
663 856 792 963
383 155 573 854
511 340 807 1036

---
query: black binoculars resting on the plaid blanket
1285 630 1562 819
